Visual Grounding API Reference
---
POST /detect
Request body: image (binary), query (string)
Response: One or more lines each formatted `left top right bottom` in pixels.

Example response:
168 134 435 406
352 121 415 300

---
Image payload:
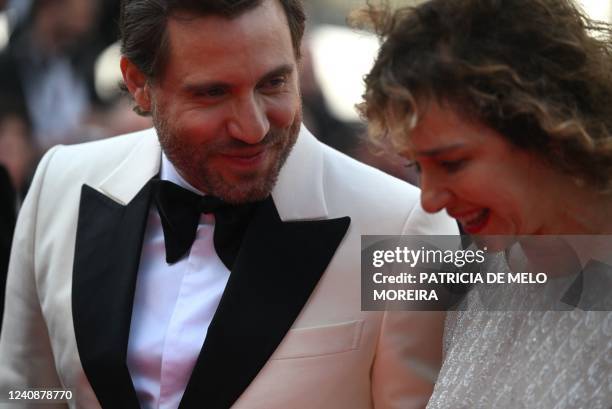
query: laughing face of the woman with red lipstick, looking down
407 102 568 235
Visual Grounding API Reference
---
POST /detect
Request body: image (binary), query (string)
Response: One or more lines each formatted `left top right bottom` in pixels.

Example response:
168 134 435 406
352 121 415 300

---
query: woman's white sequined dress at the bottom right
427 262 612 409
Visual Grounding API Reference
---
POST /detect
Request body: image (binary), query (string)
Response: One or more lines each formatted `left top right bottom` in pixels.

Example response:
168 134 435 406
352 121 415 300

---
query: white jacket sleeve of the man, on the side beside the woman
372 203 459 409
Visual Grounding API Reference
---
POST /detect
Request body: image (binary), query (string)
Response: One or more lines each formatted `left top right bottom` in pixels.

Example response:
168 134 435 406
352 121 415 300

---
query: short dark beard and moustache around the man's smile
152 108 301 204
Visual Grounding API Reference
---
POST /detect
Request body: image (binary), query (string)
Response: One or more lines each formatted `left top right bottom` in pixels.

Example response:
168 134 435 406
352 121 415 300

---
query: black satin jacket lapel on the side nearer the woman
179 199 350 409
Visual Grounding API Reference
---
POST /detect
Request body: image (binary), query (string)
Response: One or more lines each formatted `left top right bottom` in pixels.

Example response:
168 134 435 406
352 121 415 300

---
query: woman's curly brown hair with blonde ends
351 0 612 191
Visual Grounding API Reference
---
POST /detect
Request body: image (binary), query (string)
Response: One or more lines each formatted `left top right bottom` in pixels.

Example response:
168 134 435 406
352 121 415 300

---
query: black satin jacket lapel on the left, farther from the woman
72 184 151 409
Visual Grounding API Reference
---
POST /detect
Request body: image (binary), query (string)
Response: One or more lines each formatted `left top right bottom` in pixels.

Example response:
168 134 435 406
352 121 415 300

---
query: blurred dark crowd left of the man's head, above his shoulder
0 0 149 197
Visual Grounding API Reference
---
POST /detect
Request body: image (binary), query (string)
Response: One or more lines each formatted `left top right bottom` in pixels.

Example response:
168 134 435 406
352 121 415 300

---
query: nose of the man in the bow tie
227 95 270 144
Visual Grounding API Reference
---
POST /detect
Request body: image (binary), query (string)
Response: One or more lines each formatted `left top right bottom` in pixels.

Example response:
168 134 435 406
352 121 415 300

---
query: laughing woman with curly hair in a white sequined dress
357 0 612 409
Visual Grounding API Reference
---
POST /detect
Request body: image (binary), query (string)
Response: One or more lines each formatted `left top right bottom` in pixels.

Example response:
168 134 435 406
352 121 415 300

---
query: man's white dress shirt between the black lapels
127 154 230 409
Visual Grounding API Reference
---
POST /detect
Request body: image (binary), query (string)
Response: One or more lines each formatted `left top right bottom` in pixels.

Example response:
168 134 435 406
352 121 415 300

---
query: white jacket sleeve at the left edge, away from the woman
0 148 66 408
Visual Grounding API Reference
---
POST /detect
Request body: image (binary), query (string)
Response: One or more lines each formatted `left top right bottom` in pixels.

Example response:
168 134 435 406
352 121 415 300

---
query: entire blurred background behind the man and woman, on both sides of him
0 0 612 201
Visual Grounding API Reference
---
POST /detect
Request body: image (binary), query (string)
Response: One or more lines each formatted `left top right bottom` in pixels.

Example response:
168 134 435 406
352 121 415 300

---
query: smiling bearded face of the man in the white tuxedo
146 0 301 203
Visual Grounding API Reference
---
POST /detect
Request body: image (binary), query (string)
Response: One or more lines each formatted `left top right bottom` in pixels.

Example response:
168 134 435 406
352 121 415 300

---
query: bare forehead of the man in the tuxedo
160 0 295 83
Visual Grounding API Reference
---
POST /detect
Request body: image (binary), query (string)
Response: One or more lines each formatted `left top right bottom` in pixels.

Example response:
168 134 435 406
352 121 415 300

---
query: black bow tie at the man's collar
153 180 257 271
